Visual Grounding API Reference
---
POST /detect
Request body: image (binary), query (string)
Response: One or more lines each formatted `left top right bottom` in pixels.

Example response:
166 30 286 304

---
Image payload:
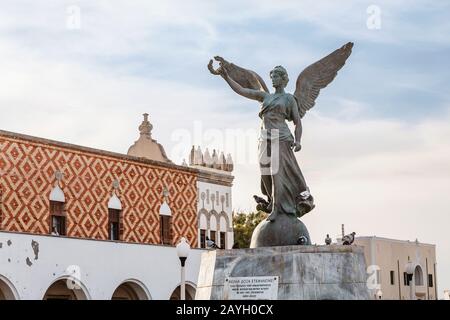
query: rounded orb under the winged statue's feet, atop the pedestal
250 214 311 248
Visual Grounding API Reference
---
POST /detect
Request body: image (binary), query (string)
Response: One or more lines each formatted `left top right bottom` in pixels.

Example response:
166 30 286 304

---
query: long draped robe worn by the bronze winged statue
258 93 313 216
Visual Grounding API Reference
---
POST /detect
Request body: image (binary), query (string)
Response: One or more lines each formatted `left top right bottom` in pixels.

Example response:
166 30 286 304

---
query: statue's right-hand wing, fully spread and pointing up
294 42 353 118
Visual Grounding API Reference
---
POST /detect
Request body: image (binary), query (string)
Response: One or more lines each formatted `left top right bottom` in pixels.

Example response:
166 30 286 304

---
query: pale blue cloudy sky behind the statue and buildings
0 0 450 293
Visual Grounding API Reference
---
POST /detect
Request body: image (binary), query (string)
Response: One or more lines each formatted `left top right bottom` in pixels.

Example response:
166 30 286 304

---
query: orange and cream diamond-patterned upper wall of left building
0 131 198 246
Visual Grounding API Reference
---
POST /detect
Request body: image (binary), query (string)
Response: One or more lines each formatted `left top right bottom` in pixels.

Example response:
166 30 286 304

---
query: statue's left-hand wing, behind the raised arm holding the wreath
208 56 269 93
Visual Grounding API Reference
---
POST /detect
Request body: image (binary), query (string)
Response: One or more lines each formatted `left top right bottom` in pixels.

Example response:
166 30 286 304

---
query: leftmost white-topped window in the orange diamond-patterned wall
49 185 66 236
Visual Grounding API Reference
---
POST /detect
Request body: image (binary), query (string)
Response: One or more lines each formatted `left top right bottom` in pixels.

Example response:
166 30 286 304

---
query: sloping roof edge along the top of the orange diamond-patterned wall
0 130 199 174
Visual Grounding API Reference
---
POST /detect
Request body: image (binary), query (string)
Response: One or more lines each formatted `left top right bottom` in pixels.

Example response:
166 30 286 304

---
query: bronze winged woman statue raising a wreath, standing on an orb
208 42 353 245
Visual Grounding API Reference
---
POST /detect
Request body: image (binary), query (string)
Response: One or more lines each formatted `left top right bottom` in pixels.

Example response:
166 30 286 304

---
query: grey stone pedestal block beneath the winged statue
195 245 370 300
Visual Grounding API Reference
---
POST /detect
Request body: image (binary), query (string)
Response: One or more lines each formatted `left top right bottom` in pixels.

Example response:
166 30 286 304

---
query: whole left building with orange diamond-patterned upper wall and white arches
0 114 237 300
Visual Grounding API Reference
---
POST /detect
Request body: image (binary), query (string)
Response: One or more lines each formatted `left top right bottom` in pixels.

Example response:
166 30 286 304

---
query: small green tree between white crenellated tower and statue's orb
233 211 267 248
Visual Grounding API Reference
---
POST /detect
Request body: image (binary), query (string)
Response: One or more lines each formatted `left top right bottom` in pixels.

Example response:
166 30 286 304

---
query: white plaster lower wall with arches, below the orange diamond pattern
0 232 205 300
